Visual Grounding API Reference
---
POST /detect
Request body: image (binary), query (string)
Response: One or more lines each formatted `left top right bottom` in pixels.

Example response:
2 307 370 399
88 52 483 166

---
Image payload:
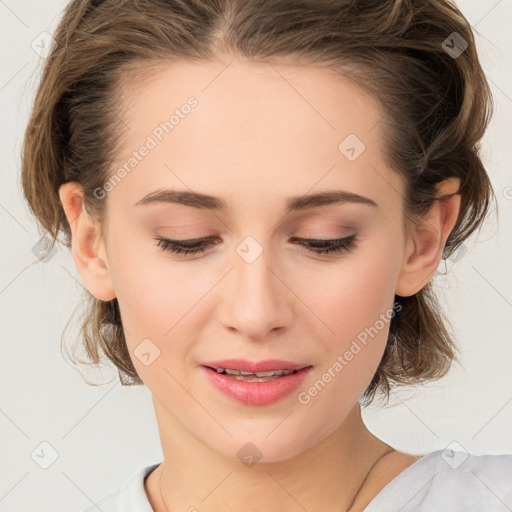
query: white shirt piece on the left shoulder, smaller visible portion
82 464 159 512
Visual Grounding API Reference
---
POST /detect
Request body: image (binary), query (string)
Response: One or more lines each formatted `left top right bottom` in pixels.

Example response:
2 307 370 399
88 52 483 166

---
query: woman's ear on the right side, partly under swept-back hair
395 178 461 297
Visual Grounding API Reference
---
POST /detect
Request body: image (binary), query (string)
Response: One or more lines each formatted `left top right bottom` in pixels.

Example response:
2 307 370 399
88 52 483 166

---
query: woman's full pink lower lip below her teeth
201 366 312 405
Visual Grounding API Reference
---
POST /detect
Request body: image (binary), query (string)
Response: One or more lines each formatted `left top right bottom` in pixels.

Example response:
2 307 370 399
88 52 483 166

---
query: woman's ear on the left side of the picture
59 182 116 301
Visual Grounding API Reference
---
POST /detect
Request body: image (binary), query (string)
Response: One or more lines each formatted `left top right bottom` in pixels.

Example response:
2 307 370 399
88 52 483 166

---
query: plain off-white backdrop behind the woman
0 0 512 512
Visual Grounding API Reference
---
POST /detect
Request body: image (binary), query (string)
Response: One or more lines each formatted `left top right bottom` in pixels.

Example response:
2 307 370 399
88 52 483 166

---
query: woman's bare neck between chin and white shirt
145 400 390 512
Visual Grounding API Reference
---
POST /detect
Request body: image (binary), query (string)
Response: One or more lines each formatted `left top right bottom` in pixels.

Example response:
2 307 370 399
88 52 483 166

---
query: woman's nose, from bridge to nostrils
218 237 294 341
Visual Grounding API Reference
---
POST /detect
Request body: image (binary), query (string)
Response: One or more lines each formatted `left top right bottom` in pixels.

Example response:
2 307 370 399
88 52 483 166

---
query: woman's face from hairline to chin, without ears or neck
102 61 405 462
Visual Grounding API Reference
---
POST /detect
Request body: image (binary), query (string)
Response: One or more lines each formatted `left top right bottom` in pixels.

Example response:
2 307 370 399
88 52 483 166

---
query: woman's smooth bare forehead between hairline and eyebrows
112 60 400 214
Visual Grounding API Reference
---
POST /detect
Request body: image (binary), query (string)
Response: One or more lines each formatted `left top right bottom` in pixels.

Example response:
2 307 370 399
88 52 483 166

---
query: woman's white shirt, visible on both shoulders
82 449 512 512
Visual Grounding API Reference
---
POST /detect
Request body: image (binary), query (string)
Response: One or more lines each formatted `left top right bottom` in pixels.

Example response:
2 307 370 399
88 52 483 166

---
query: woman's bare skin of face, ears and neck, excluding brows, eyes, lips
59 60 460 512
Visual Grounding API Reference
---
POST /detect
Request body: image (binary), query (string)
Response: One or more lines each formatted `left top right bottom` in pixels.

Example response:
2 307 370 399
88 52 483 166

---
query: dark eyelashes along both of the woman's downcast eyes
154 235 356 256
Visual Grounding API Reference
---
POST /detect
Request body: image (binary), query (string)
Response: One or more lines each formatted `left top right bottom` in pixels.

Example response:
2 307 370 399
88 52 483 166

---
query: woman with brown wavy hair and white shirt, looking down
22 0 512 512
